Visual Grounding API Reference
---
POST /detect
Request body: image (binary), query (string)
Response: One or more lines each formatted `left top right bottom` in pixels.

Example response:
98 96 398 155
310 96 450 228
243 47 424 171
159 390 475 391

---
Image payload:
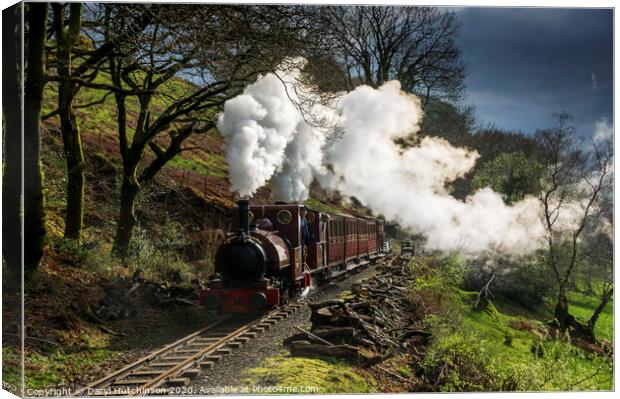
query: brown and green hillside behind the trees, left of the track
3 72 376 394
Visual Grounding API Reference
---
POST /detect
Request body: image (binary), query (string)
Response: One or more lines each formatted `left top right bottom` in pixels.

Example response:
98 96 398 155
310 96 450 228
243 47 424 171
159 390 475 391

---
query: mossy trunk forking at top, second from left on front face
52 3 84 240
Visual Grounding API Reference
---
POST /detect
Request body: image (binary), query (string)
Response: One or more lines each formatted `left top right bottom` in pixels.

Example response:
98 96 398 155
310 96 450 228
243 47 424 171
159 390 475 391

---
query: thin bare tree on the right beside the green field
536 113 613 339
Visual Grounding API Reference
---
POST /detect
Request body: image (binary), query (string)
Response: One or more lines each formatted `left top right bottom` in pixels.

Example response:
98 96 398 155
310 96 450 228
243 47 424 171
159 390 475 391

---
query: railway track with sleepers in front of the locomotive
73 302 304 396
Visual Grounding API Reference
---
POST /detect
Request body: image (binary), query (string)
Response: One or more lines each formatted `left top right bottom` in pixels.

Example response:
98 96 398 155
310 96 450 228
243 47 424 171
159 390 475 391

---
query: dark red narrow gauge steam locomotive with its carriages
200 200 385 313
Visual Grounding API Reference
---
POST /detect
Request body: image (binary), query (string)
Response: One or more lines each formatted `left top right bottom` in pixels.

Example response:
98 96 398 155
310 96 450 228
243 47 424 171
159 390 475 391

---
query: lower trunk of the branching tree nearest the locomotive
112 177 140 260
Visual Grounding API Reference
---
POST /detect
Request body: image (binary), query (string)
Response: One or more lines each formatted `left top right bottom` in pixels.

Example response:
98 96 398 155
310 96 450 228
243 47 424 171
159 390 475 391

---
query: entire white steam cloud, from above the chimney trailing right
218 62 596 255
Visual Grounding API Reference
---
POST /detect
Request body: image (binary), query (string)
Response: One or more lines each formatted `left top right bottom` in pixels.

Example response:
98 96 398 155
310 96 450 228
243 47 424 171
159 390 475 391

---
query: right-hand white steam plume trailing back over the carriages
328 82 544 253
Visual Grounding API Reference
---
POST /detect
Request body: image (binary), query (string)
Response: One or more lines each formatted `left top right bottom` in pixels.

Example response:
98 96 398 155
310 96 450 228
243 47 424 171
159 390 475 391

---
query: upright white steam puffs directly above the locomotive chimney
218 58 333 202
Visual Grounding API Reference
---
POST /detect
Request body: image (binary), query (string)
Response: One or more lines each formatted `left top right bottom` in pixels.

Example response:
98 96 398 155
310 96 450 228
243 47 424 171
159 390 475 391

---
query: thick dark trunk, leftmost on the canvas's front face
24 3 47 278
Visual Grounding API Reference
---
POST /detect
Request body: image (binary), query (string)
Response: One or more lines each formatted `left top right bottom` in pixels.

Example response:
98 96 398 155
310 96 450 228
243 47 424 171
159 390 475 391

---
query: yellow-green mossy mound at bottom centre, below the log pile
242 355 376 394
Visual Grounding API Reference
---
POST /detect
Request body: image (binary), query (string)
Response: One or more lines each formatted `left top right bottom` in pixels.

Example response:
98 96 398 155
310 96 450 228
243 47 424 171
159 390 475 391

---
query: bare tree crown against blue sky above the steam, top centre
322 6 465 102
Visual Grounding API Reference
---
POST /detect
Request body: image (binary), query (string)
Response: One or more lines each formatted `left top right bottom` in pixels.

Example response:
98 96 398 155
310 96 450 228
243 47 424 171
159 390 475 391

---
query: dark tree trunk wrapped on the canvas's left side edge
2 4 23 289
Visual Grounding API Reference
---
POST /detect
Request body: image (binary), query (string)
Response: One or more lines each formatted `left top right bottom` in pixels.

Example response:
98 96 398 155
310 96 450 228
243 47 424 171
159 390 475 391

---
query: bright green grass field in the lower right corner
413 258 613 392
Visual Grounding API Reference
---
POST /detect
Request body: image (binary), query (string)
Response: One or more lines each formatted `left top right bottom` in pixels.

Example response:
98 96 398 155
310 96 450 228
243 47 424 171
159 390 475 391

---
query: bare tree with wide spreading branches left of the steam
106 5 320 257
